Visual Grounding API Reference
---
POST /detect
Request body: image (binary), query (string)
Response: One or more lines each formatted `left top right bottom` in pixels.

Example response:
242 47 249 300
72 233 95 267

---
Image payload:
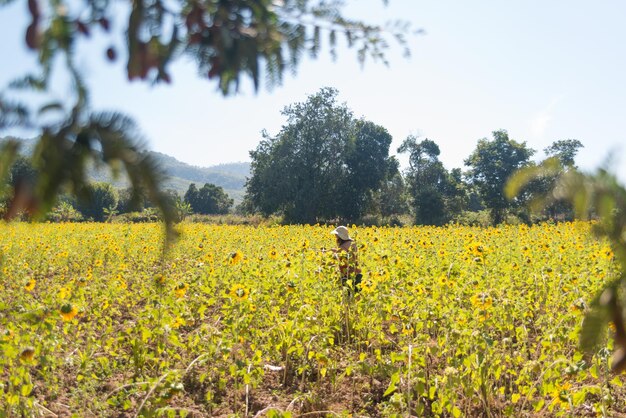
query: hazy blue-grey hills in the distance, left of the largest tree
0 139 250 204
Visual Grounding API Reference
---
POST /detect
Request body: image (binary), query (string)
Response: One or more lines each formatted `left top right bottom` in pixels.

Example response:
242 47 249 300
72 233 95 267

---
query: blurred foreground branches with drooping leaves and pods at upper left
0 0 408 237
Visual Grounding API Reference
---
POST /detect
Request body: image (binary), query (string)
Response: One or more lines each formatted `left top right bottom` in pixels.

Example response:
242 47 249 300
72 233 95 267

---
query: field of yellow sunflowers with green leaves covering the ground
0 222 626 417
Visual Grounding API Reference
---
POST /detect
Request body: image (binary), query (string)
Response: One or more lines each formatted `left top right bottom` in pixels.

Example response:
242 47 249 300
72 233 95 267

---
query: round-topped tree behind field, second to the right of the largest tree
465 130 535 224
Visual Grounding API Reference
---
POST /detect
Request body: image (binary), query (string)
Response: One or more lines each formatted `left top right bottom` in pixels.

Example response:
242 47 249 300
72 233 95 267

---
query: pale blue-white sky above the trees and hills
0 0 626 183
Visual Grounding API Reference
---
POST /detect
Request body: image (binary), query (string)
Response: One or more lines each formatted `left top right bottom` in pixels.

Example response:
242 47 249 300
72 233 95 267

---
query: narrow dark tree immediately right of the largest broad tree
398 135 455 225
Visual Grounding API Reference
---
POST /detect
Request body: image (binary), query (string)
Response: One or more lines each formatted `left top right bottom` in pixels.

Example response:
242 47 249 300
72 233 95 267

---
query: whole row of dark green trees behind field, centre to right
243 88 583 225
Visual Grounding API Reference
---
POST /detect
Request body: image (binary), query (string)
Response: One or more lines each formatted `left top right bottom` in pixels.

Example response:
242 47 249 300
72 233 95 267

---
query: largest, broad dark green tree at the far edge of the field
246 88 393 223
